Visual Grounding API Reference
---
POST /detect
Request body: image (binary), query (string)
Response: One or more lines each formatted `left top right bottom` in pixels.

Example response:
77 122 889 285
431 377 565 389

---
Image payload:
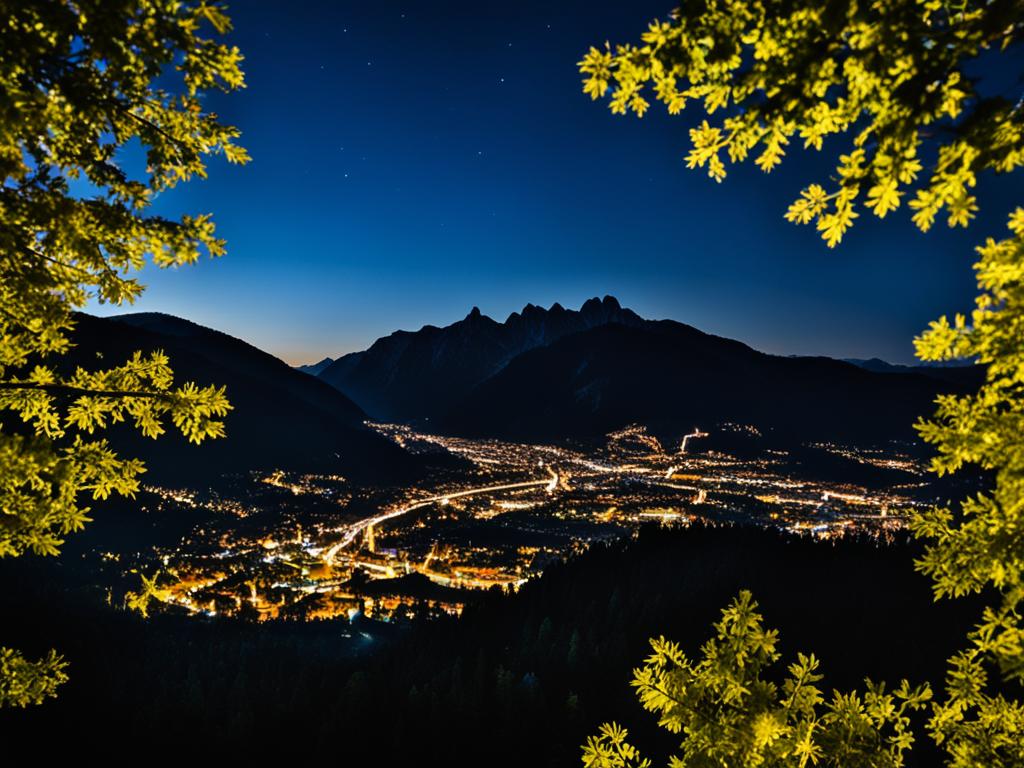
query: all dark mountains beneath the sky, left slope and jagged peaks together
54 296 981 481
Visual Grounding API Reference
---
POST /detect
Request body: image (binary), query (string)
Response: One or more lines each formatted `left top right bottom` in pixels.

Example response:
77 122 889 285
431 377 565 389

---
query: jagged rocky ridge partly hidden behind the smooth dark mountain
319 296 646 420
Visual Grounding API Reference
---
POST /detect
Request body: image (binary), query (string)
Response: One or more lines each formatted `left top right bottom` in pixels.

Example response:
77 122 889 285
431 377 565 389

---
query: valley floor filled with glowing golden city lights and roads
102 423 934 622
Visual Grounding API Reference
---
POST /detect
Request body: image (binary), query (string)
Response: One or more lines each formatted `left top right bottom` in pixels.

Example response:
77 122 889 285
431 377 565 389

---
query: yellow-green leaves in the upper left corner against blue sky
0 0 248 376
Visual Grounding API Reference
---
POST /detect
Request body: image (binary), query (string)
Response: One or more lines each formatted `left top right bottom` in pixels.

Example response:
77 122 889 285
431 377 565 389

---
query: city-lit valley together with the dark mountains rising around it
36 296 977 623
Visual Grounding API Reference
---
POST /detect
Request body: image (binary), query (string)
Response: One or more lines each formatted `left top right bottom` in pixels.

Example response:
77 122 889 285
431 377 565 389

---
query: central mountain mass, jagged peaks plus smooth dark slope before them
305 296 980 442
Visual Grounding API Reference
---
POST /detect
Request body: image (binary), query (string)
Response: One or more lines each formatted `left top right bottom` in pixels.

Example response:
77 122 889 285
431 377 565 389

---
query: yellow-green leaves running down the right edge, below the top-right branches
912 209 1024 768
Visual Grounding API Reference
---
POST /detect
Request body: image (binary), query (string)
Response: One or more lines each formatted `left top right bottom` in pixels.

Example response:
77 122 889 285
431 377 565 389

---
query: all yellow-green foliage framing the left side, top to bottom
0 0 248 705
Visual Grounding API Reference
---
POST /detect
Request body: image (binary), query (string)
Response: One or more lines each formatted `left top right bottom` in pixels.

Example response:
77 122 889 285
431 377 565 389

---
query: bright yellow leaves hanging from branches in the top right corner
580 0 1024 246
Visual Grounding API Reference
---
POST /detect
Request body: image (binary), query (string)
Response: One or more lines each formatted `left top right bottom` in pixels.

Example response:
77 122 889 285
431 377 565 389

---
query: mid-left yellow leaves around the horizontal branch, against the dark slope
0 339 230 557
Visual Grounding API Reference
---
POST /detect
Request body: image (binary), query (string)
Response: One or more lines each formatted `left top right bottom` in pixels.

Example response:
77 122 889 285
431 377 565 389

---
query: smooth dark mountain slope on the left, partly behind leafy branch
61 313 420 483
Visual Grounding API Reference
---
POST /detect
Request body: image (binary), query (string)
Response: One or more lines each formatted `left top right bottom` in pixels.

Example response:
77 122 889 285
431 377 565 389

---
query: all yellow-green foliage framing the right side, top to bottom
580 0 1024 768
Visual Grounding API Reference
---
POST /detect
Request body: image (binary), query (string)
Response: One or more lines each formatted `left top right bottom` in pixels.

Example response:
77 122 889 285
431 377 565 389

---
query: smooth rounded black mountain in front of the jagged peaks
437 321 966 441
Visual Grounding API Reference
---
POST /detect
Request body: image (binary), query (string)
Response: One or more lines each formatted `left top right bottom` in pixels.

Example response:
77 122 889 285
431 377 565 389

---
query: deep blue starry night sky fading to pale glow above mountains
90 0 1019 362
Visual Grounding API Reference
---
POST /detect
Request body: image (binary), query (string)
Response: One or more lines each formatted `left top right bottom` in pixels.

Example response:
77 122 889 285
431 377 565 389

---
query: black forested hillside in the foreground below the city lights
0 527 974 766
